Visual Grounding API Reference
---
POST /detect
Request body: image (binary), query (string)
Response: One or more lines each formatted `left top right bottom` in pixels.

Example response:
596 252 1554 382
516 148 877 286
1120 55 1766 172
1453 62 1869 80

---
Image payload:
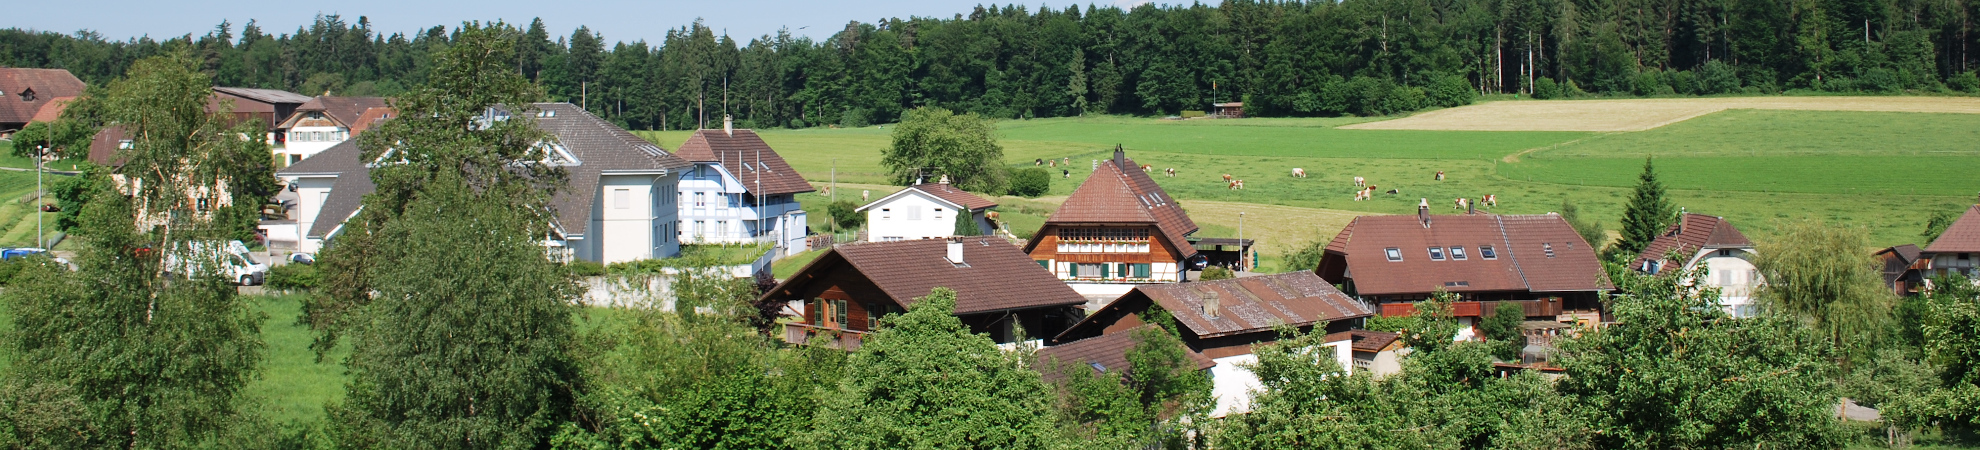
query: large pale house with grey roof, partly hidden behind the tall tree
261 103 693 264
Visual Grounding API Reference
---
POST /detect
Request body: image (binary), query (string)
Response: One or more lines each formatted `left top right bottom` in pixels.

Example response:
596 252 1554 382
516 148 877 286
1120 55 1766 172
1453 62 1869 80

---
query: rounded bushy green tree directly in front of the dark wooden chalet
798 287 1071 448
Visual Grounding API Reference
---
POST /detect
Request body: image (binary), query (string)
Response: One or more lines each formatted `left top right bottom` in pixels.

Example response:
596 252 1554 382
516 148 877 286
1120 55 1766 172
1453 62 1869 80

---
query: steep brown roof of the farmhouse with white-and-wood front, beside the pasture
1024 149 1198 258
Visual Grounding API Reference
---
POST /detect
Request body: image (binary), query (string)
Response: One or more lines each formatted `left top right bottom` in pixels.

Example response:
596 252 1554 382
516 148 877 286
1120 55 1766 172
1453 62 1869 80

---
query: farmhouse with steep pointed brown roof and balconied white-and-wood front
1024 147 1196 307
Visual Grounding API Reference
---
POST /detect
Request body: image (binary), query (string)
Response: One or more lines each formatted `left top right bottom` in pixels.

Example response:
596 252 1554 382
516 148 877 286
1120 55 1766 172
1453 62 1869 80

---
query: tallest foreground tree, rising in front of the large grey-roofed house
309 22 582 448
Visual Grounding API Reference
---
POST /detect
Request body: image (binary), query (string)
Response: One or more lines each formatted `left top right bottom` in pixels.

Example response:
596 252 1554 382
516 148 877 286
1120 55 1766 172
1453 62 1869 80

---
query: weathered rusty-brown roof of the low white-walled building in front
1092 264 1374 337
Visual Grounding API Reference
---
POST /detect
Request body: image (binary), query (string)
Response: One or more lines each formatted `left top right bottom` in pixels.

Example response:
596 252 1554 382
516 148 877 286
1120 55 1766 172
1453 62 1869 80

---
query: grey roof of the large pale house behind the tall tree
275 103 693 236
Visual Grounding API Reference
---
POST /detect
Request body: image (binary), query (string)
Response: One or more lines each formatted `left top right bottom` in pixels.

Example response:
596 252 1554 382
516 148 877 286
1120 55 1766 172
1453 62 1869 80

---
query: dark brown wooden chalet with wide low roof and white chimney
760 236 1085 349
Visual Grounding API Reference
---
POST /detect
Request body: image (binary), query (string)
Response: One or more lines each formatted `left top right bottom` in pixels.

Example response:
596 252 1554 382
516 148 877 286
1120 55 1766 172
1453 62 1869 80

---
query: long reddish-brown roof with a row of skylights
1327 214 1608 295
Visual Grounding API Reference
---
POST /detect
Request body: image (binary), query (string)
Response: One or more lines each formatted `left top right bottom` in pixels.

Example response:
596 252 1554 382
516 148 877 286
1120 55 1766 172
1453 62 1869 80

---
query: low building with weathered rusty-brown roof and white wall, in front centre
1051 272 1374 414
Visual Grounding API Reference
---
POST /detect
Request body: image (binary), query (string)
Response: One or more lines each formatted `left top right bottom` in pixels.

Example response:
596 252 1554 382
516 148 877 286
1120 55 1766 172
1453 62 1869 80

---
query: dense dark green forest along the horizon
0 0 1980 129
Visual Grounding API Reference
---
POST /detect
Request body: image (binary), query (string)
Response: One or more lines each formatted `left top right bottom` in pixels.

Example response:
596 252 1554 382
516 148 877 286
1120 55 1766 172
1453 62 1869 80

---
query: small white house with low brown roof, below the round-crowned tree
857 174 996 242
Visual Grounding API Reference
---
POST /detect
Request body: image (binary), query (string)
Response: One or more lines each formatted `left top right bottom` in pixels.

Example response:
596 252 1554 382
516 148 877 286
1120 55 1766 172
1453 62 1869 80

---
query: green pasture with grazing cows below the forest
642 97 1980 255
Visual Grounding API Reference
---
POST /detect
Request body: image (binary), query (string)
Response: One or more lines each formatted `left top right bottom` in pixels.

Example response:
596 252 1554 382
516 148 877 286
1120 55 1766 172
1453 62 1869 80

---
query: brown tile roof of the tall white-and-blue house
675 129 814 194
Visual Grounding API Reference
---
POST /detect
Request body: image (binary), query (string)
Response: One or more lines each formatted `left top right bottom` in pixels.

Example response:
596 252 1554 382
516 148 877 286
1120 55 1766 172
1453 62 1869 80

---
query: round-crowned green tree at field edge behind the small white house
879 107 1010 192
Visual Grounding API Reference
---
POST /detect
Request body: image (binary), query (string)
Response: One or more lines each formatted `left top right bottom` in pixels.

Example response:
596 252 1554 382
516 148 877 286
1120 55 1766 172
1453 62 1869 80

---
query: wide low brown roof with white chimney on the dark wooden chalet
762 236 1087 313
